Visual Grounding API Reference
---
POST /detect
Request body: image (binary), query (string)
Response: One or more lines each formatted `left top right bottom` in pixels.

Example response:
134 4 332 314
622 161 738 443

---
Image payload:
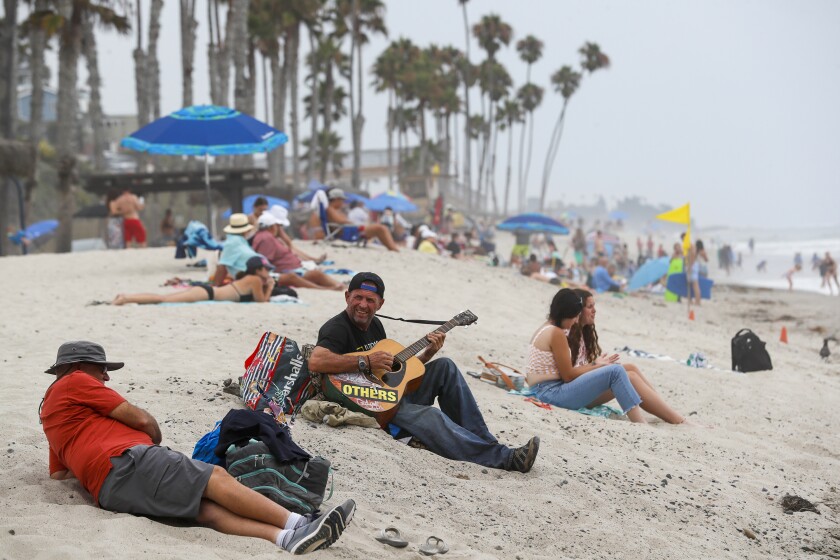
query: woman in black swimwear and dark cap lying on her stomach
111 257 274 305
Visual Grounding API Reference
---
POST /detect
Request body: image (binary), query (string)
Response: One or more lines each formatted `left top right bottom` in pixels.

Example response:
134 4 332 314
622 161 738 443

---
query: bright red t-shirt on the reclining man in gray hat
41 371 153 504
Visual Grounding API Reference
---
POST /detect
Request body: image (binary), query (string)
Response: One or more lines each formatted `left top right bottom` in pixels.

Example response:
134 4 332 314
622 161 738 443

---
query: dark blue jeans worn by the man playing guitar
391 358 513 469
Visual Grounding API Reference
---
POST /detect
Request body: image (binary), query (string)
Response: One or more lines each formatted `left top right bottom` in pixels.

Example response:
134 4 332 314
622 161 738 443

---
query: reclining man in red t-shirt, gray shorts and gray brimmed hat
40 341 356 554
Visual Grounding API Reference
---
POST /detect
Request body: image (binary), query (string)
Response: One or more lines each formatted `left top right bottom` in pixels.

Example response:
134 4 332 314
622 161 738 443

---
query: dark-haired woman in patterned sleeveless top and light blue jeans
528 288 686 424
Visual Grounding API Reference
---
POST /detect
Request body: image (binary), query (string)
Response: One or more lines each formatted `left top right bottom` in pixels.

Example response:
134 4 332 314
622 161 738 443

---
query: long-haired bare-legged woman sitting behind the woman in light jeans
568 289 699 425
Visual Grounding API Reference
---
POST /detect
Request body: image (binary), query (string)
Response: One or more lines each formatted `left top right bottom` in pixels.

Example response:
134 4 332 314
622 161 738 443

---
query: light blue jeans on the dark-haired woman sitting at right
531 364 642 414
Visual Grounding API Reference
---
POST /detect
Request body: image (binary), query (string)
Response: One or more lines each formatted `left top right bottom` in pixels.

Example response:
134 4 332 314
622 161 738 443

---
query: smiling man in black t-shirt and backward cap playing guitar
309 272 540 472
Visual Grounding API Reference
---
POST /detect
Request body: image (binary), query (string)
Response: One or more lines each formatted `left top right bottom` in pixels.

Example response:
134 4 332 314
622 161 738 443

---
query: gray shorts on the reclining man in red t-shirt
99 445 213 519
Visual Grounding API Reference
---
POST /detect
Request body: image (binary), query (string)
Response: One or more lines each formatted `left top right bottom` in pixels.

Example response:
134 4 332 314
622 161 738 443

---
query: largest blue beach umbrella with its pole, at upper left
120 105 288 234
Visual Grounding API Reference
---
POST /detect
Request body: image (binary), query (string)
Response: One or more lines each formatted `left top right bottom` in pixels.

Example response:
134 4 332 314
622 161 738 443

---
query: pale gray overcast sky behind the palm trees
44 0 840 228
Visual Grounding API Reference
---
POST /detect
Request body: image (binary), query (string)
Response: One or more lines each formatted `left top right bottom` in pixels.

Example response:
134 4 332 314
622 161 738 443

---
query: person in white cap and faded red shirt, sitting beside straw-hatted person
251 212 347 292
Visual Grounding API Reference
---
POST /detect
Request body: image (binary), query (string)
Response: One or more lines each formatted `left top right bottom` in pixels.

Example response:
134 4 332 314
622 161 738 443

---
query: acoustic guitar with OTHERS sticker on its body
323 310 478 428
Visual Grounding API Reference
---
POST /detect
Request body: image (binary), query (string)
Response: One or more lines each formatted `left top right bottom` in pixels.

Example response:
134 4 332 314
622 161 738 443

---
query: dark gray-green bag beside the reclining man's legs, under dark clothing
225 439 332 514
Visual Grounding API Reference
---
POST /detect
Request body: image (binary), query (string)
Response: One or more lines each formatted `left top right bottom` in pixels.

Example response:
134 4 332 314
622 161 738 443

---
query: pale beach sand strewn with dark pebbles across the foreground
0 248 840 560
